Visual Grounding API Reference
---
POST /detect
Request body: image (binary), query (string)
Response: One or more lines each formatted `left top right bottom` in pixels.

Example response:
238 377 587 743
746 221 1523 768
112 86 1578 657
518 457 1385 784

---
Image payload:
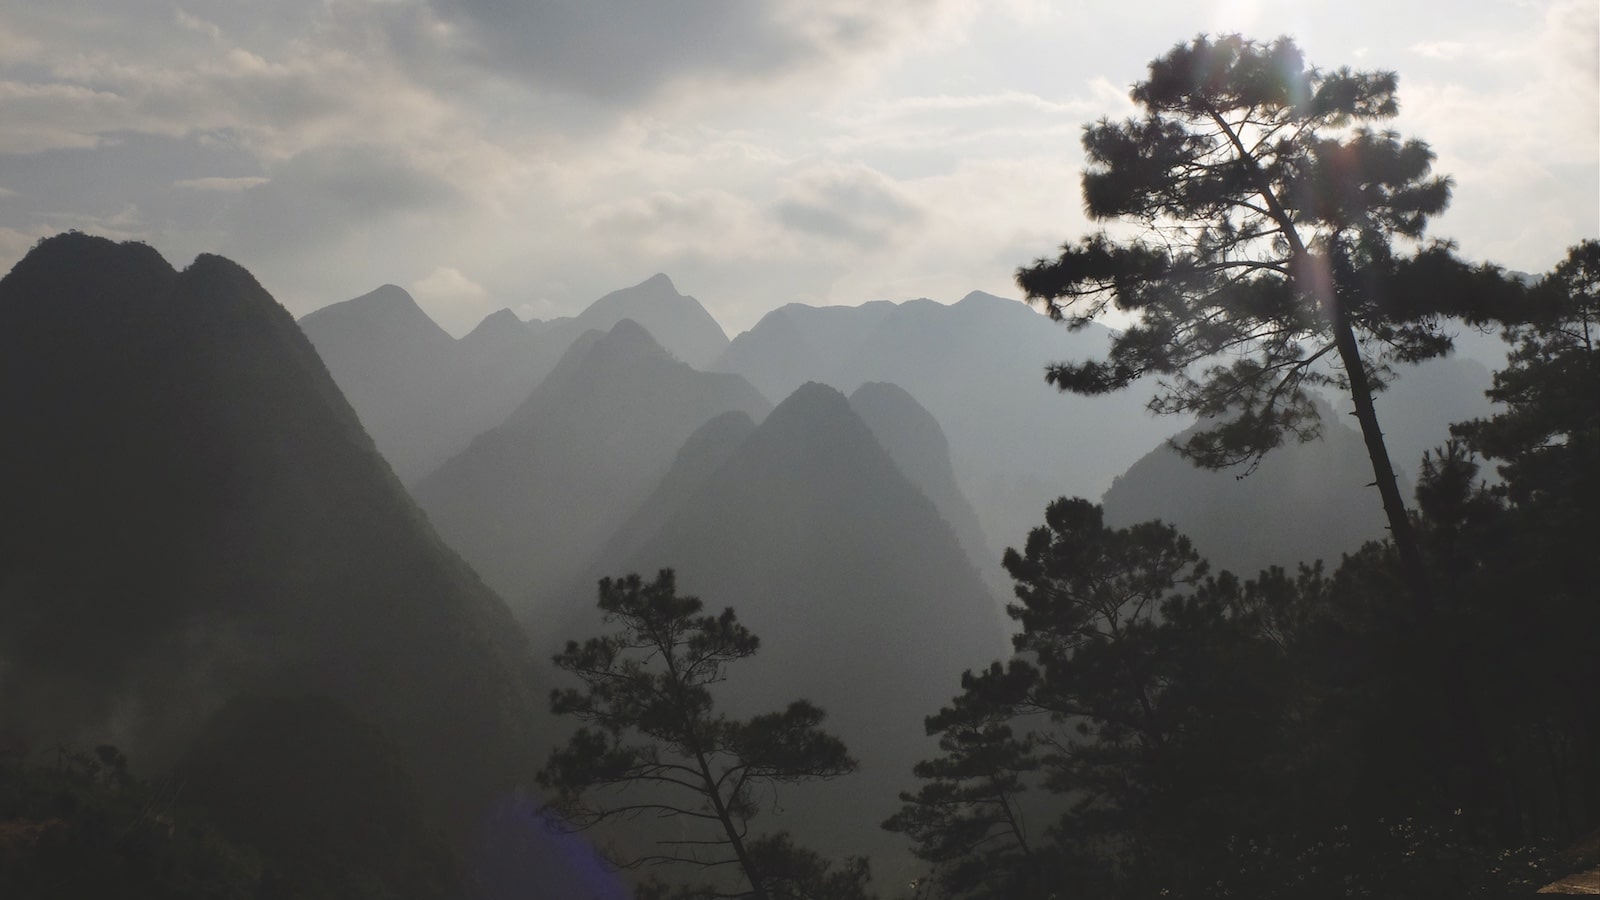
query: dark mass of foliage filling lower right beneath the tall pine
885 444 1600 898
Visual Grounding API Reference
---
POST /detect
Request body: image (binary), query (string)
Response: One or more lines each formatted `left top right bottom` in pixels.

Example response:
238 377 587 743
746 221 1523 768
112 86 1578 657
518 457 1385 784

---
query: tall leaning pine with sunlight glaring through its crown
1018 35 1502 617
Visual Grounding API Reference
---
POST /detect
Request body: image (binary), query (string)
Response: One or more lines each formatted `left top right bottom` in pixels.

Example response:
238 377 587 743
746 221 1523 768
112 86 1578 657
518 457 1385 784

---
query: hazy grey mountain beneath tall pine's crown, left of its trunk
1102 402 1405 577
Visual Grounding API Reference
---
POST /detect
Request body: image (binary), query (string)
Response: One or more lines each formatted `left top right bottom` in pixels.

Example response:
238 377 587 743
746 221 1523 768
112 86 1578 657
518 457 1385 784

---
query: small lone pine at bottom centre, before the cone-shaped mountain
538 569 867 900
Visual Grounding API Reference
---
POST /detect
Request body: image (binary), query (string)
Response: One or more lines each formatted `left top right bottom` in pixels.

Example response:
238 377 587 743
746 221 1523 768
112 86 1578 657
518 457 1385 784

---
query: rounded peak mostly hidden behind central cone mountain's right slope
850 381 1011 597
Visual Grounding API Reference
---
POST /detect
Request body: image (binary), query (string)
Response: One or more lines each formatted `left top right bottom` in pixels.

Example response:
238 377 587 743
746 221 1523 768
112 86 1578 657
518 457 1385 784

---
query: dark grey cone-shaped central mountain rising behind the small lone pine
585 384 1006 855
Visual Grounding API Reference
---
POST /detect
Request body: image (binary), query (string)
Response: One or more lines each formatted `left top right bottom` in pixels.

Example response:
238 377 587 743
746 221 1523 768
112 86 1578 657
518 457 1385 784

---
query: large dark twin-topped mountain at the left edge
0 234 534 820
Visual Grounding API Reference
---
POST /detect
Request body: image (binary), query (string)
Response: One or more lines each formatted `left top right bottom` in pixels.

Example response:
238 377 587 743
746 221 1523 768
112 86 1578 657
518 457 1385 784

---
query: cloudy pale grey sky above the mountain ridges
0 0 1600 336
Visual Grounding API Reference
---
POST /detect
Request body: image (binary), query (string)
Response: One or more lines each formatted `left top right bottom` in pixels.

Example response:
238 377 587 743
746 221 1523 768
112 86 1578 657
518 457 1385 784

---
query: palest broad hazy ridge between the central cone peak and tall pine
714 291 1173 548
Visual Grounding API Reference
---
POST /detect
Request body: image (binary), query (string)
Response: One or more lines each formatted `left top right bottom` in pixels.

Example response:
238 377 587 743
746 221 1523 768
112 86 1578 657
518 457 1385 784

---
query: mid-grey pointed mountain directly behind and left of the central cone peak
416 319 768 613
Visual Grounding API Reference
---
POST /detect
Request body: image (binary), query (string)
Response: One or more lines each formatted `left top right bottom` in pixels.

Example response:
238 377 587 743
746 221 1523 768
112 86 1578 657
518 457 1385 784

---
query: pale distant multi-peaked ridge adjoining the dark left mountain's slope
301 275 728 484
